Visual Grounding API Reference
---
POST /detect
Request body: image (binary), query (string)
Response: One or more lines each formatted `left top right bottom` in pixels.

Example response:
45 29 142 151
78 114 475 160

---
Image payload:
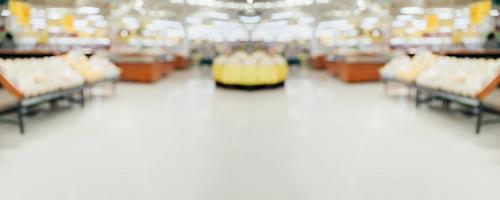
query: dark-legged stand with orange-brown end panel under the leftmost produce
0 74 85 134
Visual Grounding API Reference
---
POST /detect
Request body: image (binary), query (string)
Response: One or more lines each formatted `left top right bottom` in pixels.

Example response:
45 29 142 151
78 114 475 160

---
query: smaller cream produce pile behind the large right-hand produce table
380 51 438 83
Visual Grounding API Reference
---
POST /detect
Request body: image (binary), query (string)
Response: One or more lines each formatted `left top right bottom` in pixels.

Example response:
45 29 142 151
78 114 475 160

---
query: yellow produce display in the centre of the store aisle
212 51 288 86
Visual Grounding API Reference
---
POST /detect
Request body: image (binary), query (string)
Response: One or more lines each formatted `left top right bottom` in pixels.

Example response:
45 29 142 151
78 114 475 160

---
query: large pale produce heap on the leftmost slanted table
0 57 85 97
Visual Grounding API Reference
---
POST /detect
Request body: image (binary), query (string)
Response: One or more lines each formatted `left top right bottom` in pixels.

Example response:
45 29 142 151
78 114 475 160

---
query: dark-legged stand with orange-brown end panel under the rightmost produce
415 76 500 134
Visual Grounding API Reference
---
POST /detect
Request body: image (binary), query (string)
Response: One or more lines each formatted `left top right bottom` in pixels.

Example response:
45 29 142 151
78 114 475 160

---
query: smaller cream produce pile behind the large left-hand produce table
63 51 120 83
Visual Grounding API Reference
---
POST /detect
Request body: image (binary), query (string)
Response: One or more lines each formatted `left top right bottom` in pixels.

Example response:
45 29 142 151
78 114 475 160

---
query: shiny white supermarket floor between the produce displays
0 70 500 200
